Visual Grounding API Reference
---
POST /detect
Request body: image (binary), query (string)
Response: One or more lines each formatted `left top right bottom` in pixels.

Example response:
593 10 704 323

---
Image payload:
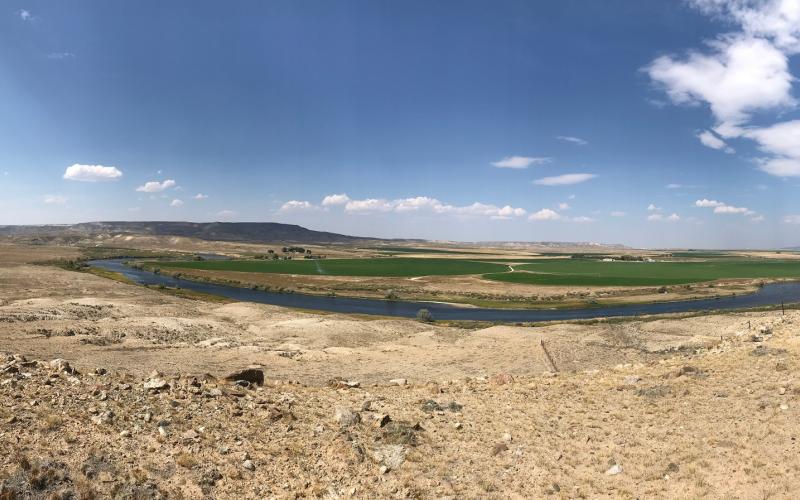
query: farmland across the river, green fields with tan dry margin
144 247 800 307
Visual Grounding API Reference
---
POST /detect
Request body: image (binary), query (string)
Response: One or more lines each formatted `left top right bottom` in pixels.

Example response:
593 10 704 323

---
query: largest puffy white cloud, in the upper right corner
645 0 800 177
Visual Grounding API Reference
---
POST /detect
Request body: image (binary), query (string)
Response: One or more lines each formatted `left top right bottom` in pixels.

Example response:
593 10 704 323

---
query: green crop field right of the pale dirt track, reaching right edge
484 257 800 286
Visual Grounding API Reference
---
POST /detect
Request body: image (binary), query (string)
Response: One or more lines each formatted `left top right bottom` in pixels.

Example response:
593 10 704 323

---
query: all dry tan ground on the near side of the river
0 245 800 498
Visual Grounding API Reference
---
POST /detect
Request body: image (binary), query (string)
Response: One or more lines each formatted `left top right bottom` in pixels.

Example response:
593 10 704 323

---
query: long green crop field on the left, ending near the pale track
147 258 508 277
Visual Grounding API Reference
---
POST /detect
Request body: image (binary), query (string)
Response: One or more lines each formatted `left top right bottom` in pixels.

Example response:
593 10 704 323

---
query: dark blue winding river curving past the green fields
89 259 800 322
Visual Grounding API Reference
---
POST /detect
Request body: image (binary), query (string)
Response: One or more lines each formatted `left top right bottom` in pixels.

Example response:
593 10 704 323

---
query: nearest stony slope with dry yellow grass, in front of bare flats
0 312 800 498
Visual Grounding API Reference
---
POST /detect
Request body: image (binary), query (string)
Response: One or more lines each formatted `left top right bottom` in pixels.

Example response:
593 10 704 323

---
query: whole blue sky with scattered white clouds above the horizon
0 0 800 248
